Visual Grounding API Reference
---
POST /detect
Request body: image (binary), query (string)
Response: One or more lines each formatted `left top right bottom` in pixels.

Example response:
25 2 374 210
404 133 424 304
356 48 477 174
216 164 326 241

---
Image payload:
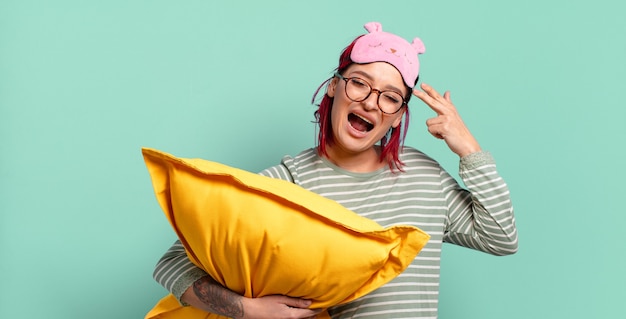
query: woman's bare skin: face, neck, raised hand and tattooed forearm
181 62 480 319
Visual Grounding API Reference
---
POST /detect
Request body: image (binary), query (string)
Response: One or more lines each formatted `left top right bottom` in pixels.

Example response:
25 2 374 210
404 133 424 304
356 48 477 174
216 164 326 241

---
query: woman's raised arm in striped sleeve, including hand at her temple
413 84 517 255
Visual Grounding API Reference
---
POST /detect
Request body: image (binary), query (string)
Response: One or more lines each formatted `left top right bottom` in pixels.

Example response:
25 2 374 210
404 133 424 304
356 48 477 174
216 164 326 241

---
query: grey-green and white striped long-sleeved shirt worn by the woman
154 147 517 319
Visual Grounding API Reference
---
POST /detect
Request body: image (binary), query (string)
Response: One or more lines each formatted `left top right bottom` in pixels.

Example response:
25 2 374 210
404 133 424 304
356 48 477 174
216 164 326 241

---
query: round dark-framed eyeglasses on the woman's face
335 72 406 114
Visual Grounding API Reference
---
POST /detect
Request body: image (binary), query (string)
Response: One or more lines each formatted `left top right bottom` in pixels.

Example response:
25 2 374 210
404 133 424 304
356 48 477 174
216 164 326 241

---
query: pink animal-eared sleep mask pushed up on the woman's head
350 22 426 88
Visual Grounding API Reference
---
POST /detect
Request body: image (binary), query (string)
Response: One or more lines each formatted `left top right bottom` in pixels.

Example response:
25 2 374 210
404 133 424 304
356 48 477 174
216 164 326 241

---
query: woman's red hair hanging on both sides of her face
313 36 413 171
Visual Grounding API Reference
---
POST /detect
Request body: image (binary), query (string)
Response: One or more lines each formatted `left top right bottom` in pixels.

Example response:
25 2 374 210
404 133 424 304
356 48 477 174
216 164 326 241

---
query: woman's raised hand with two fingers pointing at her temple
413 84 480 157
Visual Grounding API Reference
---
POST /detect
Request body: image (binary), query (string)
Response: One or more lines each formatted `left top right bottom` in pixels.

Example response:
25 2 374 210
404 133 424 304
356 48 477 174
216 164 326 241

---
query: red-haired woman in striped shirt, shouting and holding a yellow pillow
154 22 517 318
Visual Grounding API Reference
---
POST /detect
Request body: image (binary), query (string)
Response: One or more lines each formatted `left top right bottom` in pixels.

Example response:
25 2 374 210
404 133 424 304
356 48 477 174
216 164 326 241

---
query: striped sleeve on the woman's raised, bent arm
442 152 518 256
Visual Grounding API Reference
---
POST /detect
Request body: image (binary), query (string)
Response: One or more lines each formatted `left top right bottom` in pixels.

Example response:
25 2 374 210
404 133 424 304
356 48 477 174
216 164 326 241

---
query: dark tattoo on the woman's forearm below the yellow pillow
193 276 243 318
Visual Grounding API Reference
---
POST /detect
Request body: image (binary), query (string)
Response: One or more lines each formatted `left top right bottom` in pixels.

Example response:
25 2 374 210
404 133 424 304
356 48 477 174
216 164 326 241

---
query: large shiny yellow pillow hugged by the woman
142 148 429 318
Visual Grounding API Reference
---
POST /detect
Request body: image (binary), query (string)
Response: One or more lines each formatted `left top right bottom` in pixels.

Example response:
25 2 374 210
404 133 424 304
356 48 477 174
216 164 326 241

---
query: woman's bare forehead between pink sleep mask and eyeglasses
344 62 407 93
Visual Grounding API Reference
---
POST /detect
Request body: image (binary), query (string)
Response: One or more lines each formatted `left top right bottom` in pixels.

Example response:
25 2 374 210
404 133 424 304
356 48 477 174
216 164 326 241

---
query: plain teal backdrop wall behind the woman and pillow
0 0 626 319
